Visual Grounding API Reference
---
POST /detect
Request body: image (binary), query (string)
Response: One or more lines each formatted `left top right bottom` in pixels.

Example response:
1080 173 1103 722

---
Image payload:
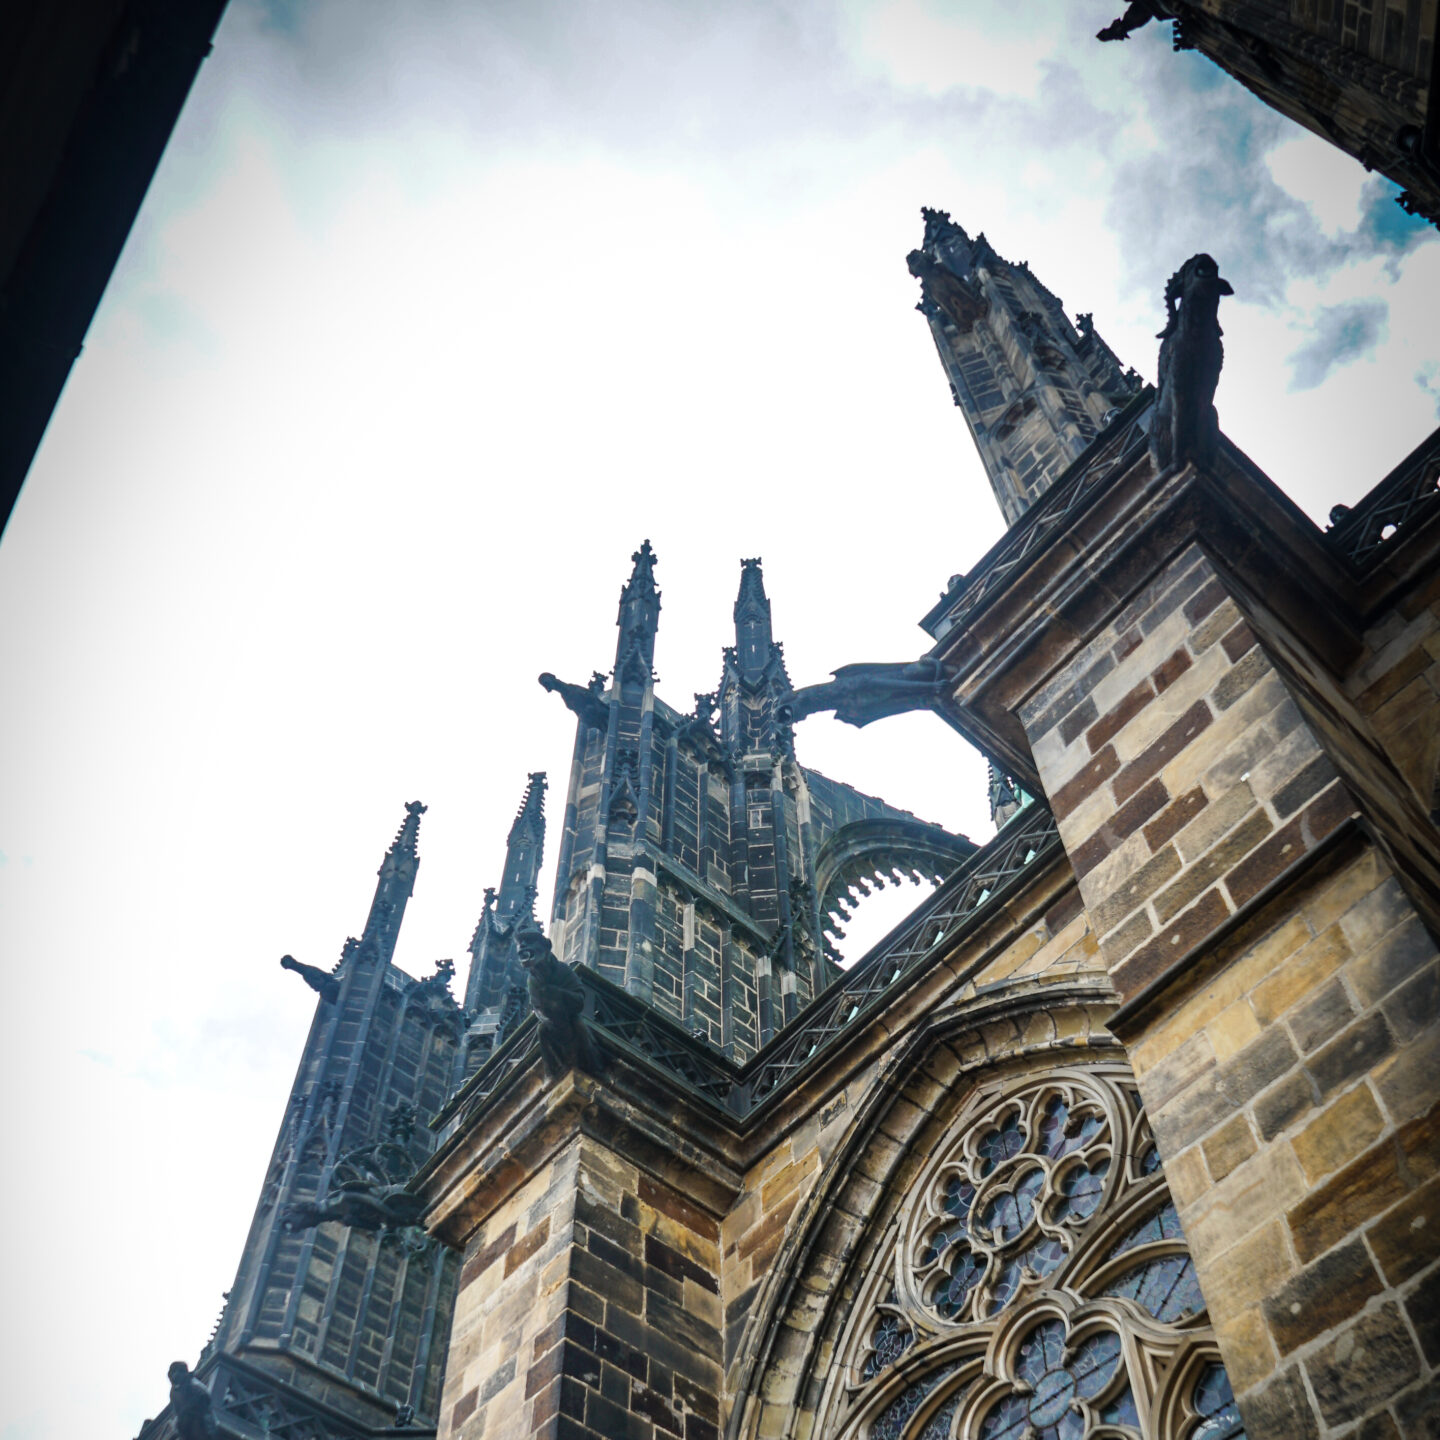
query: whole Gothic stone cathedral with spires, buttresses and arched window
143 212 1440 1440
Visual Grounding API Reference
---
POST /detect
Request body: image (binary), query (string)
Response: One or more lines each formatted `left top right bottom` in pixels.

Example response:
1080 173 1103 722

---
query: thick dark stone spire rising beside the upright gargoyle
907 209 1140 524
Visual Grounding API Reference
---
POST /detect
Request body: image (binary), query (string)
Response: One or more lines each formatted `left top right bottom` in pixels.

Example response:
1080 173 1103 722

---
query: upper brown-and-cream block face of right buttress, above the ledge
1021 547 1355 999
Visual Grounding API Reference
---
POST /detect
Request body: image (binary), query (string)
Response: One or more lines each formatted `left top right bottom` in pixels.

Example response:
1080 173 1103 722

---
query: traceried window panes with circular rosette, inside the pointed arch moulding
816 1064 1244 1440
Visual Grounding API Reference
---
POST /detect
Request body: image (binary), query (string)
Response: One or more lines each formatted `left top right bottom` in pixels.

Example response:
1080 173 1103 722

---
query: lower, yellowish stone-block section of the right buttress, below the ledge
1130 845 1440 1437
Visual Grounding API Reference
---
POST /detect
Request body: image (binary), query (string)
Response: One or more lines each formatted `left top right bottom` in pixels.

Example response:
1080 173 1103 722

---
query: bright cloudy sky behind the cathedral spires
0 0 1440 1440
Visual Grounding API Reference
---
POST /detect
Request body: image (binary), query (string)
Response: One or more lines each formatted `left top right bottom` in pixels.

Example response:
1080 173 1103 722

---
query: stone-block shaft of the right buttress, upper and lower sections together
1021 547 1440 1440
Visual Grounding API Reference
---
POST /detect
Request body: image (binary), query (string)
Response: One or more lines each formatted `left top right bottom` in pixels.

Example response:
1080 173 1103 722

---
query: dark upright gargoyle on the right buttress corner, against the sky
1151 255 1234 469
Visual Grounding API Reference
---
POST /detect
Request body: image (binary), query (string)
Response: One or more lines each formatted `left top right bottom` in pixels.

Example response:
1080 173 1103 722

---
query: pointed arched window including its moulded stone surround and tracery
729 982 1240 1440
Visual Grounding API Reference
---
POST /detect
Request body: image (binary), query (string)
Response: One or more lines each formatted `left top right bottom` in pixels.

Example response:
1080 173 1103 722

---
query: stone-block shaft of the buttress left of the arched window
439 1133 720 1440
